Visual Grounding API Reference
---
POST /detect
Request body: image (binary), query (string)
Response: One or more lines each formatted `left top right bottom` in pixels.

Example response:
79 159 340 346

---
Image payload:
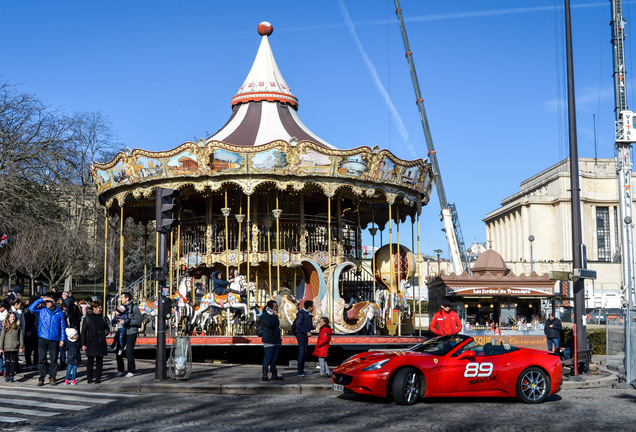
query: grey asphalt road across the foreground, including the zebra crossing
0 386 636 432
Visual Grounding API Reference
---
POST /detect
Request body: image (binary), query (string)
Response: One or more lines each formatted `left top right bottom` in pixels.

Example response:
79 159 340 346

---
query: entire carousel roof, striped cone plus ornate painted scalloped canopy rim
91 23 436 219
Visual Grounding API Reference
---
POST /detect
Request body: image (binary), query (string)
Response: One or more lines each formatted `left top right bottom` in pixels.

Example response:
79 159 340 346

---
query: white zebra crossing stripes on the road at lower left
0 386 138 424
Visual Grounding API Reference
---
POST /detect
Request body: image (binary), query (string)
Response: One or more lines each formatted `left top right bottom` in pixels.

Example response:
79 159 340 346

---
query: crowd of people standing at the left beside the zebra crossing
0 286 142 386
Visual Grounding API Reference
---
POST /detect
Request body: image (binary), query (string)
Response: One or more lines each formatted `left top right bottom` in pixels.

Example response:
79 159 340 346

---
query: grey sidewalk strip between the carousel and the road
7 354 617 395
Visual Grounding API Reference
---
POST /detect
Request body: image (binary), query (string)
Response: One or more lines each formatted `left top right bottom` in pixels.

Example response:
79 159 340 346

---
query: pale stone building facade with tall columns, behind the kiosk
484 158 634 308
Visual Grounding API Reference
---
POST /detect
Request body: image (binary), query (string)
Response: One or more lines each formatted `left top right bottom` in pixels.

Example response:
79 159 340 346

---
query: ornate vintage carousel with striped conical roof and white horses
91 23 435 336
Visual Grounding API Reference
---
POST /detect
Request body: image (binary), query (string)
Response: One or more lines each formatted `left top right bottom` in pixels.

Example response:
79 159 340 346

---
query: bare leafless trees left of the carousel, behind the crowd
0 82 115 285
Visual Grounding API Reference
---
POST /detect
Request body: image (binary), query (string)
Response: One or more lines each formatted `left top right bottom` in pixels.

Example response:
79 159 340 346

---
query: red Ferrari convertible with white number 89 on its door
332 335 563 405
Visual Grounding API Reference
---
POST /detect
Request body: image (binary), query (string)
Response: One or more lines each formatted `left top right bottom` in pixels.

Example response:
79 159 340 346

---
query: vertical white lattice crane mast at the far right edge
610 0 636 383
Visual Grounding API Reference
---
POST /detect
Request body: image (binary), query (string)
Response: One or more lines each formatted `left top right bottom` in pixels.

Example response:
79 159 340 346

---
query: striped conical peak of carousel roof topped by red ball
209 22 336 149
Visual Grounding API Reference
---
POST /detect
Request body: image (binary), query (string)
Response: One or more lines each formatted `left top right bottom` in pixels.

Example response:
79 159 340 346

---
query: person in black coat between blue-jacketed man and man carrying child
82 302 110 384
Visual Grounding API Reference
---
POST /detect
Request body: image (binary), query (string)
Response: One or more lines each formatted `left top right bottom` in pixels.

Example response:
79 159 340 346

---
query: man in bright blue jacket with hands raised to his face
29 297 66 386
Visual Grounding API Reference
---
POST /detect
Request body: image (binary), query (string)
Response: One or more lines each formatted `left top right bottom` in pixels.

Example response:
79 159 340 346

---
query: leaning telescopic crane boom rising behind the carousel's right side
395 0 469 274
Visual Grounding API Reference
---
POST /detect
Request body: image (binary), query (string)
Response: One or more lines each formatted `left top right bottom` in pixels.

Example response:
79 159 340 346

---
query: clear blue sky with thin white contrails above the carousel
0 0 636 256
